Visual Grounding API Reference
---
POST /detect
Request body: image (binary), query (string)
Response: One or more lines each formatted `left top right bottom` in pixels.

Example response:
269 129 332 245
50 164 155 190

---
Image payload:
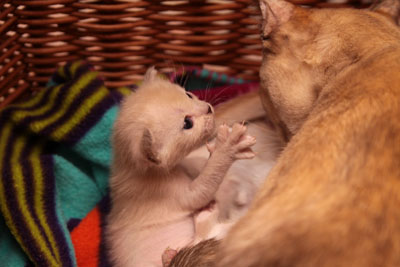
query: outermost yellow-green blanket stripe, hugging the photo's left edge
0 123 28 255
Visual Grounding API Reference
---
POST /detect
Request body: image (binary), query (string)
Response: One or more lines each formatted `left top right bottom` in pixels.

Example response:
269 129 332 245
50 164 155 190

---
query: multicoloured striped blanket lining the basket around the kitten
0 61 257 267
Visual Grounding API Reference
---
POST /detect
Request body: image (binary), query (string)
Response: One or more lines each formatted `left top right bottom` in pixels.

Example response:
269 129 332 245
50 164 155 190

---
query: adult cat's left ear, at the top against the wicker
260 0 295 36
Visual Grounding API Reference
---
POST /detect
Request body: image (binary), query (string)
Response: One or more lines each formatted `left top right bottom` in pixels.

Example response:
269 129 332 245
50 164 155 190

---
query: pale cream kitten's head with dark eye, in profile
113 68 215 170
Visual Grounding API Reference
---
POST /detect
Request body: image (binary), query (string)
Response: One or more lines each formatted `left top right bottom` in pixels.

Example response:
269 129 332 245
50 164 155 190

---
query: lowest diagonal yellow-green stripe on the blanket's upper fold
51 86 108 140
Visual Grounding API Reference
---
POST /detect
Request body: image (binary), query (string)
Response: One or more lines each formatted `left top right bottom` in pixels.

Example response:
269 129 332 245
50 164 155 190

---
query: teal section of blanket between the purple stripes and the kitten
54 106 118 222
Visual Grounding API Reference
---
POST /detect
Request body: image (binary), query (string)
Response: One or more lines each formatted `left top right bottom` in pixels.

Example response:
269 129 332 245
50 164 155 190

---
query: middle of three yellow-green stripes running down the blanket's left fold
11 137 59 266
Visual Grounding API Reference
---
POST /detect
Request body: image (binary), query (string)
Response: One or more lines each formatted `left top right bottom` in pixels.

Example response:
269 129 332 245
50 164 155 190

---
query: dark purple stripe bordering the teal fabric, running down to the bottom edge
40 154 73 266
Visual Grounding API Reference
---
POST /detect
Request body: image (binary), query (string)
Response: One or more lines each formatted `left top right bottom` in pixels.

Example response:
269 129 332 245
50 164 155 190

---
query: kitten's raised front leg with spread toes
181 123 256 210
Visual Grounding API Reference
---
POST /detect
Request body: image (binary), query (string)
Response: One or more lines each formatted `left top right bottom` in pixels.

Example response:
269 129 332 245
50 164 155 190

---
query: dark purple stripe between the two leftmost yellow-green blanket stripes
2 129 49 266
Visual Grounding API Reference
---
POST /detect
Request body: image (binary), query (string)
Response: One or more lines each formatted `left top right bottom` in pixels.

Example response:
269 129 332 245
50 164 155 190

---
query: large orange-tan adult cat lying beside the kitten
216 0 400 267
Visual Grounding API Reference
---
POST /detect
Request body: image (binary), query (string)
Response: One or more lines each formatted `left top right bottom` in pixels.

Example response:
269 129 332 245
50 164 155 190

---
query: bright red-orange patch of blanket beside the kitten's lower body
71 207 101 267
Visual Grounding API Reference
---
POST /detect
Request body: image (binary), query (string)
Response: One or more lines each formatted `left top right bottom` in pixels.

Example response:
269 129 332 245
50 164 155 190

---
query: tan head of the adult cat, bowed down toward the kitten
260 0 400 141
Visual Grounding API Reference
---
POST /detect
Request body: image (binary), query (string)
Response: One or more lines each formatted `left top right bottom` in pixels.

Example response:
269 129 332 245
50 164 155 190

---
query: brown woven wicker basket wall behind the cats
0 0 368 107
